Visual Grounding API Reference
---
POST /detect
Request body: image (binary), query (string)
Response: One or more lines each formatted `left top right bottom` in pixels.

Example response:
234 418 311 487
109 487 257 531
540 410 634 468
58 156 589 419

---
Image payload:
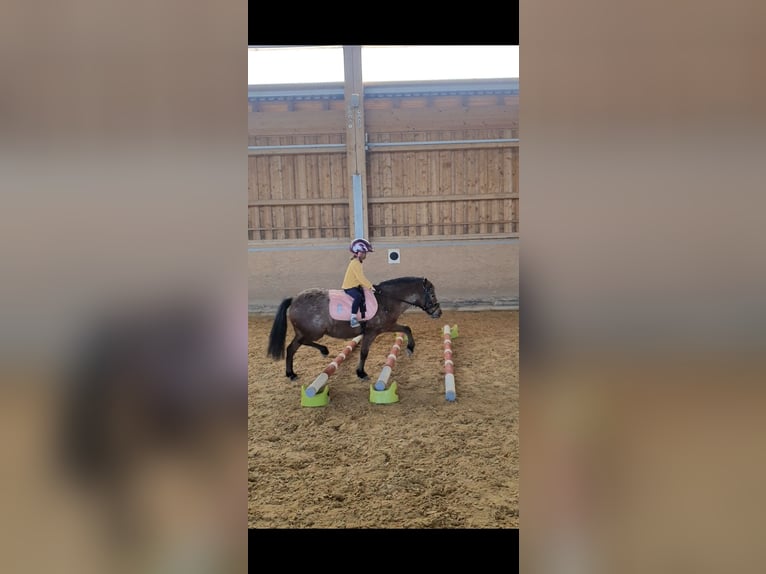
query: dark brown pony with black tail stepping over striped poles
267 277 442 380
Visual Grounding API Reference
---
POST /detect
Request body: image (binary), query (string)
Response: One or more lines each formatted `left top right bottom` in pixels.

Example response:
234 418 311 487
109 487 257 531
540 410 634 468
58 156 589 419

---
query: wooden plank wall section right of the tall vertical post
365 96 519 239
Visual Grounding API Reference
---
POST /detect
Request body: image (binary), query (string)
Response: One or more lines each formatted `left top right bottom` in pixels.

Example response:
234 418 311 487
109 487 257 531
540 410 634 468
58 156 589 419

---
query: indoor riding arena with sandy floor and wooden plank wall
248 46 520 529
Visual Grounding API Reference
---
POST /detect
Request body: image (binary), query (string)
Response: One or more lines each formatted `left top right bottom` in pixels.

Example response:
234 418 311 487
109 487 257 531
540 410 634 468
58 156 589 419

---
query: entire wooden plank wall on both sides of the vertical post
248 86 519 241
